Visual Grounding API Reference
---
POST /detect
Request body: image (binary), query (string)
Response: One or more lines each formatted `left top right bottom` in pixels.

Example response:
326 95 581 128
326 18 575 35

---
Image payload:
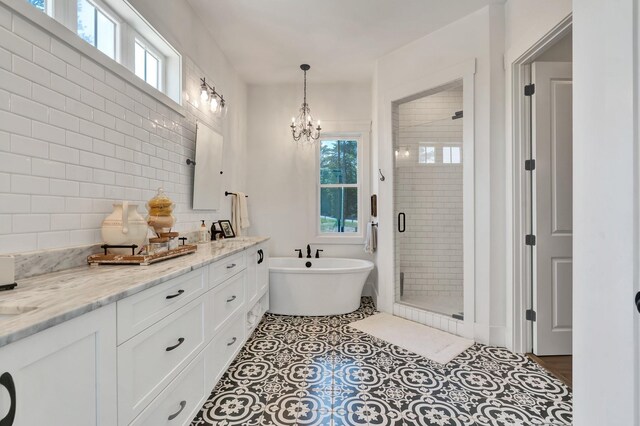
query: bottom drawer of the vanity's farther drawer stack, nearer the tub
206 312 245 388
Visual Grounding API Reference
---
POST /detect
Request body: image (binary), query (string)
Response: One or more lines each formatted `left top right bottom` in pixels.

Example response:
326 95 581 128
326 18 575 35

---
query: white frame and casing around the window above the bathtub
309 122 371 245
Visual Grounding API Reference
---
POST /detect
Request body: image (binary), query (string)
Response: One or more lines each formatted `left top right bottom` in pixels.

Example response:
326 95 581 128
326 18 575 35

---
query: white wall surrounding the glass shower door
374 5 506 344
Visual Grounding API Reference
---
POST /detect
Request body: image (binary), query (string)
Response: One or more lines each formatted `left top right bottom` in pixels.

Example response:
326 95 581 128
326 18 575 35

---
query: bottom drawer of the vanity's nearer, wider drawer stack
131 354 211 426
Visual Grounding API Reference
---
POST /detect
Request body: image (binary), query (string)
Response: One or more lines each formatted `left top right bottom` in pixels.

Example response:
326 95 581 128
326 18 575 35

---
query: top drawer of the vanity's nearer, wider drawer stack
117 268 207 344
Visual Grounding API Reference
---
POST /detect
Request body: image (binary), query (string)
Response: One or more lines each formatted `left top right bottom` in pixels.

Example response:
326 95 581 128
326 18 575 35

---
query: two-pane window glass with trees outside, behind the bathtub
319 139 361 235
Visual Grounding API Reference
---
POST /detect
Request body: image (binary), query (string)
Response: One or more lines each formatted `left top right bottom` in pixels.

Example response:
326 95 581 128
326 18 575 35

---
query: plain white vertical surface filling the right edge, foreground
573 0 640 426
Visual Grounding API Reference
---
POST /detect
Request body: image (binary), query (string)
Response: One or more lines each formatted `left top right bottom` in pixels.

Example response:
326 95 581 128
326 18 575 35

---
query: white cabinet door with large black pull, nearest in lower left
0 303 117 426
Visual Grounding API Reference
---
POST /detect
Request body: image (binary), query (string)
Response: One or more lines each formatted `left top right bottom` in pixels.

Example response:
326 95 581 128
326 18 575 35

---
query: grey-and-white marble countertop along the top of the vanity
0 237 268 347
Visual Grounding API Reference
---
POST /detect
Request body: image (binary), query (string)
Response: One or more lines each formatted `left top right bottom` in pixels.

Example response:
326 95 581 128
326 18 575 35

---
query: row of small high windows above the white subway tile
26 0 182 104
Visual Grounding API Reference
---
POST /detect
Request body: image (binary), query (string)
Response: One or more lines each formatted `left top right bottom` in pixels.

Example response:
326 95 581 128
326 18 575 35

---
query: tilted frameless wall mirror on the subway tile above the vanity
193 123 223 210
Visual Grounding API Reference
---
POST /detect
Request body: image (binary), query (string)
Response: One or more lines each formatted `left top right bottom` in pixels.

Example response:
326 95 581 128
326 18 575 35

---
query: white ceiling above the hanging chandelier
187 0 500 84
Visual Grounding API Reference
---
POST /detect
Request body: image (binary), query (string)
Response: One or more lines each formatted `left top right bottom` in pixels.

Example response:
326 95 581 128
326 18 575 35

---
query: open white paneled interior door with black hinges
531 62 573 355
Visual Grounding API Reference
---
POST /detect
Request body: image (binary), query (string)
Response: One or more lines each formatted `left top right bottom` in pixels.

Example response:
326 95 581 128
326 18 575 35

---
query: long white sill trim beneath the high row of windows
0 0 186 117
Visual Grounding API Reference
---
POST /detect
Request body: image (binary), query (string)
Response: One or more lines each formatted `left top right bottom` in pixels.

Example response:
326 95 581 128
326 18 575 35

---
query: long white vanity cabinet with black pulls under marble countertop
0 241 268 426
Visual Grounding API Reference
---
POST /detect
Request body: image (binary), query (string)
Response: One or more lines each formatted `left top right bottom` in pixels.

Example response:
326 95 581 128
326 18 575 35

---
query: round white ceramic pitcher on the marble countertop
102 201 149 254
